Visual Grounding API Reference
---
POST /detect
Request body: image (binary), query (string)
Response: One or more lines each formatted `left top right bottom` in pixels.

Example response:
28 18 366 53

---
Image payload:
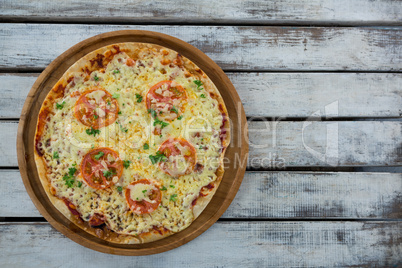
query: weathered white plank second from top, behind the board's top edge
0 23 402 71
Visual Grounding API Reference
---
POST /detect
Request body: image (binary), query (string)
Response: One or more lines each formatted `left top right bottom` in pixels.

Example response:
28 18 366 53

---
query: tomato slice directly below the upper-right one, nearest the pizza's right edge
159 138 197 178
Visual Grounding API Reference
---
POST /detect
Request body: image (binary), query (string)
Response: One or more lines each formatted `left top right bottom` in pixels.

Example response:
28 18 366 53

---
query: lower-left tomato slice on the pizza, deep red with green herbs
81 148 123 189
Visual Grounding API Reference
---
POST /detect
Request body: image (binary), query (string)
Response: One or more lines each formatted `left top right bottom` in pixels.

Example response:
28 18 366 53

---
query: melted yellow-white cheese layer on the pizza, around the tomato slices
37 45 223 238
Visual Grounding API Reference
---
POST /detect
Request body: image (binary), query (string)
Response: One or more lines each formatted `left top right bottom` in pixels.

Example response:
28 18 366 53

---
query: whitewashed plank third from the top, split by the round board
0 73 402 119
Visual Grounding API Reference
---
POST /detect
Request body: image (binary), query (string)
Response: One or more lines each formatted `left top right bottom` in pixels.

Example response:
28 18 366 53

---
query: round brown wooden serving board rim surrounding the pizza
17 30 248 255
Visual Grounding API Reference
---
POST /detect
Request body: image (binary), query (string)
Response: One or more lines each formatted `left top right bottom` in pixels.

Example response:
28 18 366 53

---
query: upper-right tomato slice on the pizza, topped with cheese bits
146 80 187 121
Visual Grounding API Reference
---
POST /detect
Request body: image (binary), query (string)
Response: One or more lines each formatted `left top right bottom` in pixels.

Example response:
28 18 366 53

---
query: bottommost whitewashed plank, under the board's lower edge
0 222 402 268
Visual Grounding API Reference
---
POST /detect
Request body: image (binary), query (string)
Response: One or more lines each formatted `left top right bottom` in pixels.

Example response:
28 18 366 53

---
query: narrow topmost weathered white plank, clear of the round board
0 0 402 25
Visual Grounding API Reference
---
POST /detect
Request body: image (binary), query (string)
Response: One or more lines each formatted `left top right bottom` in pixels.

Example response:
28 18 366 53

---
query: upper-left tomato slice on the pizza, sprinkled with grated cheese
74 88 119 129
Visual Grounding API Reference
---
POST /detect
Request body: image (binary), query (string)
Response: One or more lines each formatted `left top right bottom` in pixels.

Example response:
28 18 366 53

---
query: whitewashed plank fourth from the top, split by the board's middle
0 121 402 166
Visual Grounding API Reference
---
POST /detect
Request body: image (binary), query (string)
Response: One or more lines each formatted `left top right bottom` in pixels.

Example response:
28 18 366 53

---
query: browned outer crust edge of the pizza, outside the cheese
34 43 230 244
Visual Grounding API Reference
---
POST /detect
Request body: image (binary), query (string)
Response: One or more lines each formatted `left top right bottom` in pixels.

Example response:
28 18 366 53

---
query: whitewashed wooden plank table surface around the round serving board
0 0 402 267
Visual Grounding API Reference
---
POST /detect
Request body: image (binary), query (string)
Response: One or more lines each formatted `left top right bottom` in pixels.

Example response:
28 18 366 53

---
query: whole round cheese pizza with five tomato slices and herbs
34 42 230 244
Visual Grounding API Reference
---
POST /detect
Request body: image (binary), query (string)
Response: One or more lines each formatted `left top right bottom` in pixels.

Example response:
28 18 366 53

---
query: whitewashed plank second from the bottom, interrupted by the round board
0 170 402 219
